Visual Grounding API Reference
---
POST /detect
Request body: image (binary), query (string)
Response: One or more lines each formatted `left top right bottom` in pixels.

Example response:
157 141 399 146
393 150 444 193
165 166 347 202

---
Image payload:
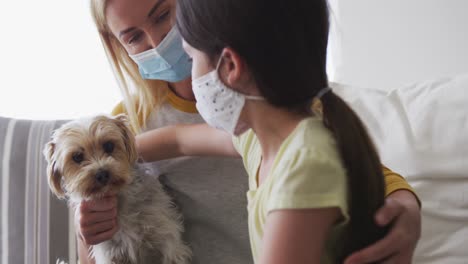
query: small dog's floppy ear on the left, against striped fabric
43 141 65 199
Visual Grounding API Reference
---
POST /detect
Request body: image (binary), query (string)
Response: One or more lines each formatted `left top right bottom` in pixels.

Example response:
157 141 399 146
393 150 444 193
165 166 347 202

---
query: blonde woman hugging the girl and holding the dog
76 0 420 264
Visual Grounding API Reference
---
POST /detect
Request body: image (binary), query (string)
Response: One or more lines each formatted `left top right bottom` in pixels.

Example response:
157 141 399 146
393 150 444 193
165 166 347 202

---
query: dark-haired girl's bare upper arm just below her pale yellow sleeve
259 208 340 264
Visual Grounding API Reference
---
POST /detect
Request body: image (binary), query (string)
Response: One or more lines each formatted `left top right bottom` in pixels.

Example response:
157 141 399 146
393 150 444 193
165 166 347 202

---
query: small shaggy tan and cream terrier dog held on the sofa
44 115 191 264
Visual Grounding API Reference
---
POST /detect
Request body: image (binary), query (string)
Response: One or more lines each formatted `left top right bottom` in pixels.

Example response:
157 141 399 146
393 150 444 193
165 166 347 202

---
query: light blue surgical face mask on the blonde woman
130 27 192 82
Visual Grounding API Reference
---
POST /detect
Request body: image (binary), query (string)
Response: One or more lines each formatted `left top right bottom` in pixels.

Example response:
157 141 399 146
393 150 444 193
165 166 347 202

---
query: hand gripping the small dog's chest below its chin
75 195 118 245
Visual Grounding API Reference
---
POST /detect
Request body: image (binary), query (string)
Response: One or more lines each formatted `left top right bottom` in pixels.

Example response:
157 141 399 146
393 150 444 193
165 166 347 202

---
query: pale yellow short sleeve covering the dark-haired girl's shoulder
267 118 347 217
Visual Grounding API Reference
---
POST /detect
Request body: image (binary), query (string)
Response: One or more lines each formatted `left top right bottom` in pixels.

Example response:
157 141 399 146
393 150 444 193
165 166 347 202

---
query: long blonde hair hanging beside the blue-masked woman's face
90 0 168 133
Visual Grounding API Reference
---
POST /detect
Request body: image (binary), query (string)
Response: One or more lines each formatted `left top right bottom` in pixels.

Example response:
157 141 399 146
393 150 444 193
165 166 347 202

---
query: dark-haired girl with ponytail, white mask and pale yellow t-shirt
133 0 420 263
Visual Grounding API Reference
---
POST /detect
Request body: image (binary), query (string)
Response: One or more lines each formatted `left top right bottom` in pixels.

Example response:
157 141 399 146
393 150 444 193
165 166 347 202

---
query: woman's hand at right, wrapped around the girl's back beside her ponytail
345 190 421 264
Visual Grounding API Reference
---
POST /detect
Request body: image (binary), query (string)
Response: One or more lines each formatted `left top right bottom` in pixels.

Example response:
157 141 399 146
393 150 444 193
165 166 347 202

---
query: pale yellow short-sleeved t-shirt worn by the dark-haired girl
233 117 348 261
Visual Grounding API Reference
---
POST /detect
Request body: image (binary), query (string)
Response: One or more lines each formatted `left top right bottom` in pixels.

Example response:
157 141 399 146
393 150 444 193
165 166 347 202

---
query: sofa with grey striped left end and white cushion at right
0 74 468 264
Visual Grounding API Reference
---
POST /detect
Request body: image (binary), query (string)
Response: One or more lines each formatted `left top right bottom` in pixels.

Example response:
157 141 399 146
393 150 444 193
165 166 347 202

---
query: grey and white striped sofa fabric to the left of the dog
0 117 76 264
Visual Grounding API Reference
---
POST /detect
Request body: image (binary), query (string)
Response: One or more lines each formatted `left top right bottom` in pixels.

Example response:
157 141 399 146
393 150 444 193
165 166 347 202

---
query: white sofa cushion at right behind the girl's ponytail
331 74 468 264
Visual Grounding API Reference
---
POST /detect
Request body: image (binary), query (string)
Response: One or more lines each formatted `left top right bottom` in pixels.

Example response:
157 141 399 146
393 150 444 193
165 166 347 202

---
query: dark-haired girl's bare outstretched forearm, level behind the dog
136 124 239 162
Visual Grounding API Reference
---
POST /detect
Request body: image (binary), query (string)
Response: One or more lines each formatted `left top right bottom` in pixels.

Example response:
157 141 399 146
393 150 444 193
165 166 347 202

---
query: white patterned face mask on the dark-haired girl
192 57 265 135
